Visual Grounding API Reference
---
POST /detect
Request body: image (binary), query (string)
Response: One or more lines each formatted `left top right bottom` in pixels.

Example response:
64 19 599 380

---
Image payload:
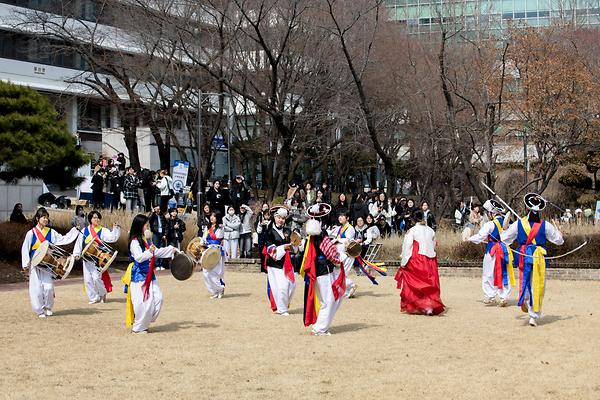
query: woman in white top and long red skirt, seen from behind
395 210 444 315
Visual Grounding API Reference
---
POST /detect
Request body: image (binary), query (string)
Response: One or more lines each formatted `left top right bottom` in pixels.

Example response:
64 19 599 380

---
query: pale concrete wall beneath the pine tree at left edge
0 179 43 221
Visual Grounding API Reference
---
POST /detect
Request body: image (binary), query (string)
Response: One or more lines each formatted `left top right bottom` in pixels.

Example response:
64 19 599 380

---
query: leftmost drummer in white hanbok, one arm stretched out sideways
21 207 79 318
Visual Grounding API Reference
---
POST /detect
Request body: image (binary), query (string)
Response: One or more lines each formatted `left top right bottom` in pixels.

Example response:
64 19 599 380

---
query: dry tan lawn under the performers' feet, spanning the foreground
0 271 600 400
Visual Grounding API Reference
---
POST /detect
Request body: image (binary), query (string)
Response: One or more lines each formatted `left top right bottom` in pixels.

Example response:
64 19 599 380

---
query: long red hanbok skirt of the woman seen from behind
395 241 444 315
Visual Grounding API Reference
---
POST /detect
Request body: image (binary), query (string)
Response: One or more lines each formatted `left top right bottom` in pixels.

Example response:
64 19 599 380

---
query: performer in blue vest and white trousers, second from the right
467 200 515 307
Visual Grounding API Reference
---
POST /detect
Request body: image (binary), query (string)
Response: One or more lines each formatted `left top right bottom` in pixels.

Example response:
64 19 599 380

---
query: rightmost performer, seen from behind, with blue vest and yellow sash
500 193 564 326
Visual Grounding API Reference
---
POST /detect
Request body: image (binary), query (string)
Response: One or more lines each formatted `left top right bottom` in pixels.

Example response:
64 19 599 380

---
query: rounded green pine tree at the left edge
0 82 89 187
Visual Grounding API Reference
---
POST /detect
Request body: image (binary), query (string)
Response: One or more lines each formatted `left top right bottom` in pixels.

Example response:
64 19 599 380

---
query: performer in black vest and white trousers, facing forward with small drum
264 207 296 316
